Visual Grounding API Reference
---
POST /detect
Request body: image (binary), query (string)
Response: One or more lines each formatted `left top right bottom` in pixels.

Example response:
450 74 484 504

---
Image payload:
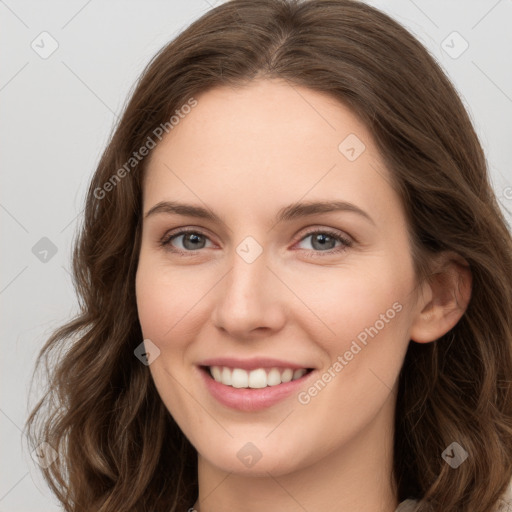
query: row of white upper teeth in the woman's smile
210 366 307 389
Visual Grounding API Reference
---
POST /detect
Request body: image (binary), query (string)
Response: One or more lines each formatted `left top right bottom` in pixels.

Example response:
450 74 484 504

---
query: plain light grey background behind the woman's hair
0 0 512 512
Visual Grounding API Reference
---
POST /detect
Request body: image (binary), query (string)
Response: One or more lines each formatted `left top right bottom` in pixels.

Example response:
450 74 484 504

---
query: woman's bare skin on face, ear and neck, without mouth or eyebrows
136 80 470 512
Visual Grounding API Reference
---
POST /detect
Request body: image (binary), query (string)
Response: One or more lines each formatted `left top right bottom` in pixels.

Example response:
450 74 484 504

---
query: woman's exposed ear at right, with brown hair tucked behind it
410 251 473 343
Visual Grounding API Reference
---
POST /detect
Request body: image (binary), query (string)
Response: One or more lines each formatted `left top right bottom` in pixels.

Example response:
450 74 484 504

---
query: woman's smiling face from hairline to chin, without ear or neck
136 80 424 475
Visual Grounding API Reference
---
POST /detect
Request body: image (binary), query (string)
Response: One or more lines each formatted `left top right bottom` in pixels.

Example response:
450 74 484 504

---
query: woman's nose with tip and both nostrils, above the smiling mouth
212 246 286 338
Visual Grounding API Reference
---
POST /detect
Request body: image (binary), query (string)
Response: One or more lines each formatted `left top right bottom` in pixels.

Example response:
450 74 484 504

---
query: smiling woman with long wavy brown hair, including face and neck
27 0 512 512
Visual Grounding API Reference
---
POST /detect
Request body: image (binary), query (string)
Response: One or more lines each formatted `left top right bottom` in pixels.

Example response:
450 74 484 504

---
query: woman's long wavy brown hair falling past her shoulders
27 0 512 512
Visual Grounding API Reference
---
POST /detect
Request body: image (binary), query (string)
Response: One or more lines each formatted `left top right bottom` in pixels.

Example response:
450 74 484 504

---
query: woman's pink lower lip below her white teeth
199 368 315 412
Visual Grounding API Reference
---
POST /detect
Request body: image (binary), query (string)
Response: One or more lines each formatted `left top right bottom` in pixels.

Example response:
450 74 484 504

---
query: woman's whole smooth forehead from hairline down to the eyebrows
144 80 396 222
